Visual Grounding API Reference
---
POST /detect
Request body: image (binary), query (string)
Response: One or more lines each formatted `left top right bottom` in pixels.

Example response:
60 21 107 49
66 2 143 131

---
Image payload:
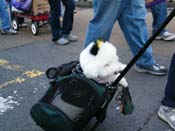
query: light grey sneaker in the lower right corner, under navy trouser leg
157 106 175 130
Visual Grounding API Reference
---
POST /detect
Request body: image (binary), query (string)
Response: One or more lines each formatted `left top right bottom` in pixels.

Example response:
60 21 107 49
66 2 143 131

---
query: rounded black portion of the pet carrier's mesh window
59 78 96 108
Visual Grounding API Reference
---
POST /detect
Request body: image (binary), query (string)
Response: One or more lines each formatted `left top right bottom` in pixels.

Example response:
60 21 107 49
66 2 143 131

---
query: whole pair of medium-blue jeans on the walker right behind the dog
85 0 155 67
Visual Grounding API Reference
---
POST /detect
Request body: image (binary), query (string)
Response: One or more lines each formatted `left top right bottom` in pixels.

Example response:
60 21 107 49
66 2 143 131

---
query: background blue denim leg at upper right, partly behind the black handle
151 1 167 35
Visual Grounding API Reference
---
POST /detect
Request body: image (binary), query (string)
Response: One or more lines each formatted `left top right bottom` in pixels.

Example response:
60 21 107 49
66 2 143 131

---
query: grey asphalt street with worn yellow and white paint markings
0 8 175 131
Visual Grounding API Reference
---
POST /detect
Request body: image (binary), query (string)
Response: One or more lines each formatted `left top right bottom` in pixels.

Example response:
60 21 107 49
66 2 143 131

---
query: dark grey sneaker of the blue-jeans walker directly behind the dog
134 64 167 76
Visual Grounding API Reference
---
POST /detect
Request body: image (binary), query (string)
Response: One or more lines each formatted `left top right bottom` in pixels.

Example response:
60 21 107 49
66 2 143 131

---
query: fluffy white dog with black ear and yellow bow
80 40 128 87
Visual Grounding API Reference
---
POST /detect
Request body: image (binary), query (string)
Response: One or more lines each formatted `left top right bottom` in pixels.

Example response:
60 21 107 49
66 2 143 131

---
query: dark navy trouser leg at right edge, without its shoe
162 53 175 107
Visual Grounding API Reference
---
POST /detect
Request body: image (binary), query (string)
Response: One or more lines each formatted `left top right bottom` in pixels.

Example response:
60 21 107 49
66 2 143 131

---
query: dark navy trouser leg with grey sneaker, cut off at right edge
157 54 175 130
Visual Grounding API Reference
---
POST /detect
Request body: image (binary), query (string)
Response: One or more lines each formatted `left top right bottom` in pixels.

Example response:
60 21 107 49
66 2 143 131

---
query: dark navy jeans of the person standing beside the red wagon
49 0 75 41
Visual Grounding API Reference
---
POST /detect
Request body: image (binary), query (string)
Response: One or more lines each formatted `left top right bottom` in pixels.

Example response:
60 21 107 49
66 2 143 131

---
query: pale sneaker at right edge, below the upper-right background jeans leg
156 31 175 41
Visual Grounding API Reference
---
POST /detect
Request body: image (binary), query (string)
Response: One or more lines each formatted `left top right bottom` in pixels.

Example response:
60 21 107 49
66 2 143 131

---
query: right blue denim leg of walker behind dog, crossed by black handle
119 0 155 67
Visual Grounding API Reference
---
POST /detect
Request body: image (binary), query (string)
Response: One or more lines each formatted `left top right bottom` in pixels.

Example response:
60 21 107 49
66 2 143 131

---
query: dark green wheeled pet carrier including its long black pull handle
30 9 175 131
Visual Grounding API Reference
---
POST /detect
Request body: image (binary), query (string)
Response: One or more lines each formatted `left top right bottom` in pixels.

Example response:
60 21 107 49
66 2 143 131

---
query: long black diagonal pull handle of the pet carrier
112 8 175 86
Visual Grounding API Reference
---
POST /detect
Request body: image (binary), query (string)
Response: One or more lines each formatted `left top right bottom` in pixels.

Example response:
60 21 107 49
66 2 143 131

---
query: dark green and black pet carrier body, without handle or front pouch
30 62 108 131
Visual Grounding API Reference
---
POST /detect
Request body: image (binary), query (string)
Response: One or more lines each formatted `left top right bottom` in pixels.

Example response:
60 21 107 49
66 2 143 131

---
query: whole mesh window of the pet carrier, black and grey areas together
51 77 97 120
